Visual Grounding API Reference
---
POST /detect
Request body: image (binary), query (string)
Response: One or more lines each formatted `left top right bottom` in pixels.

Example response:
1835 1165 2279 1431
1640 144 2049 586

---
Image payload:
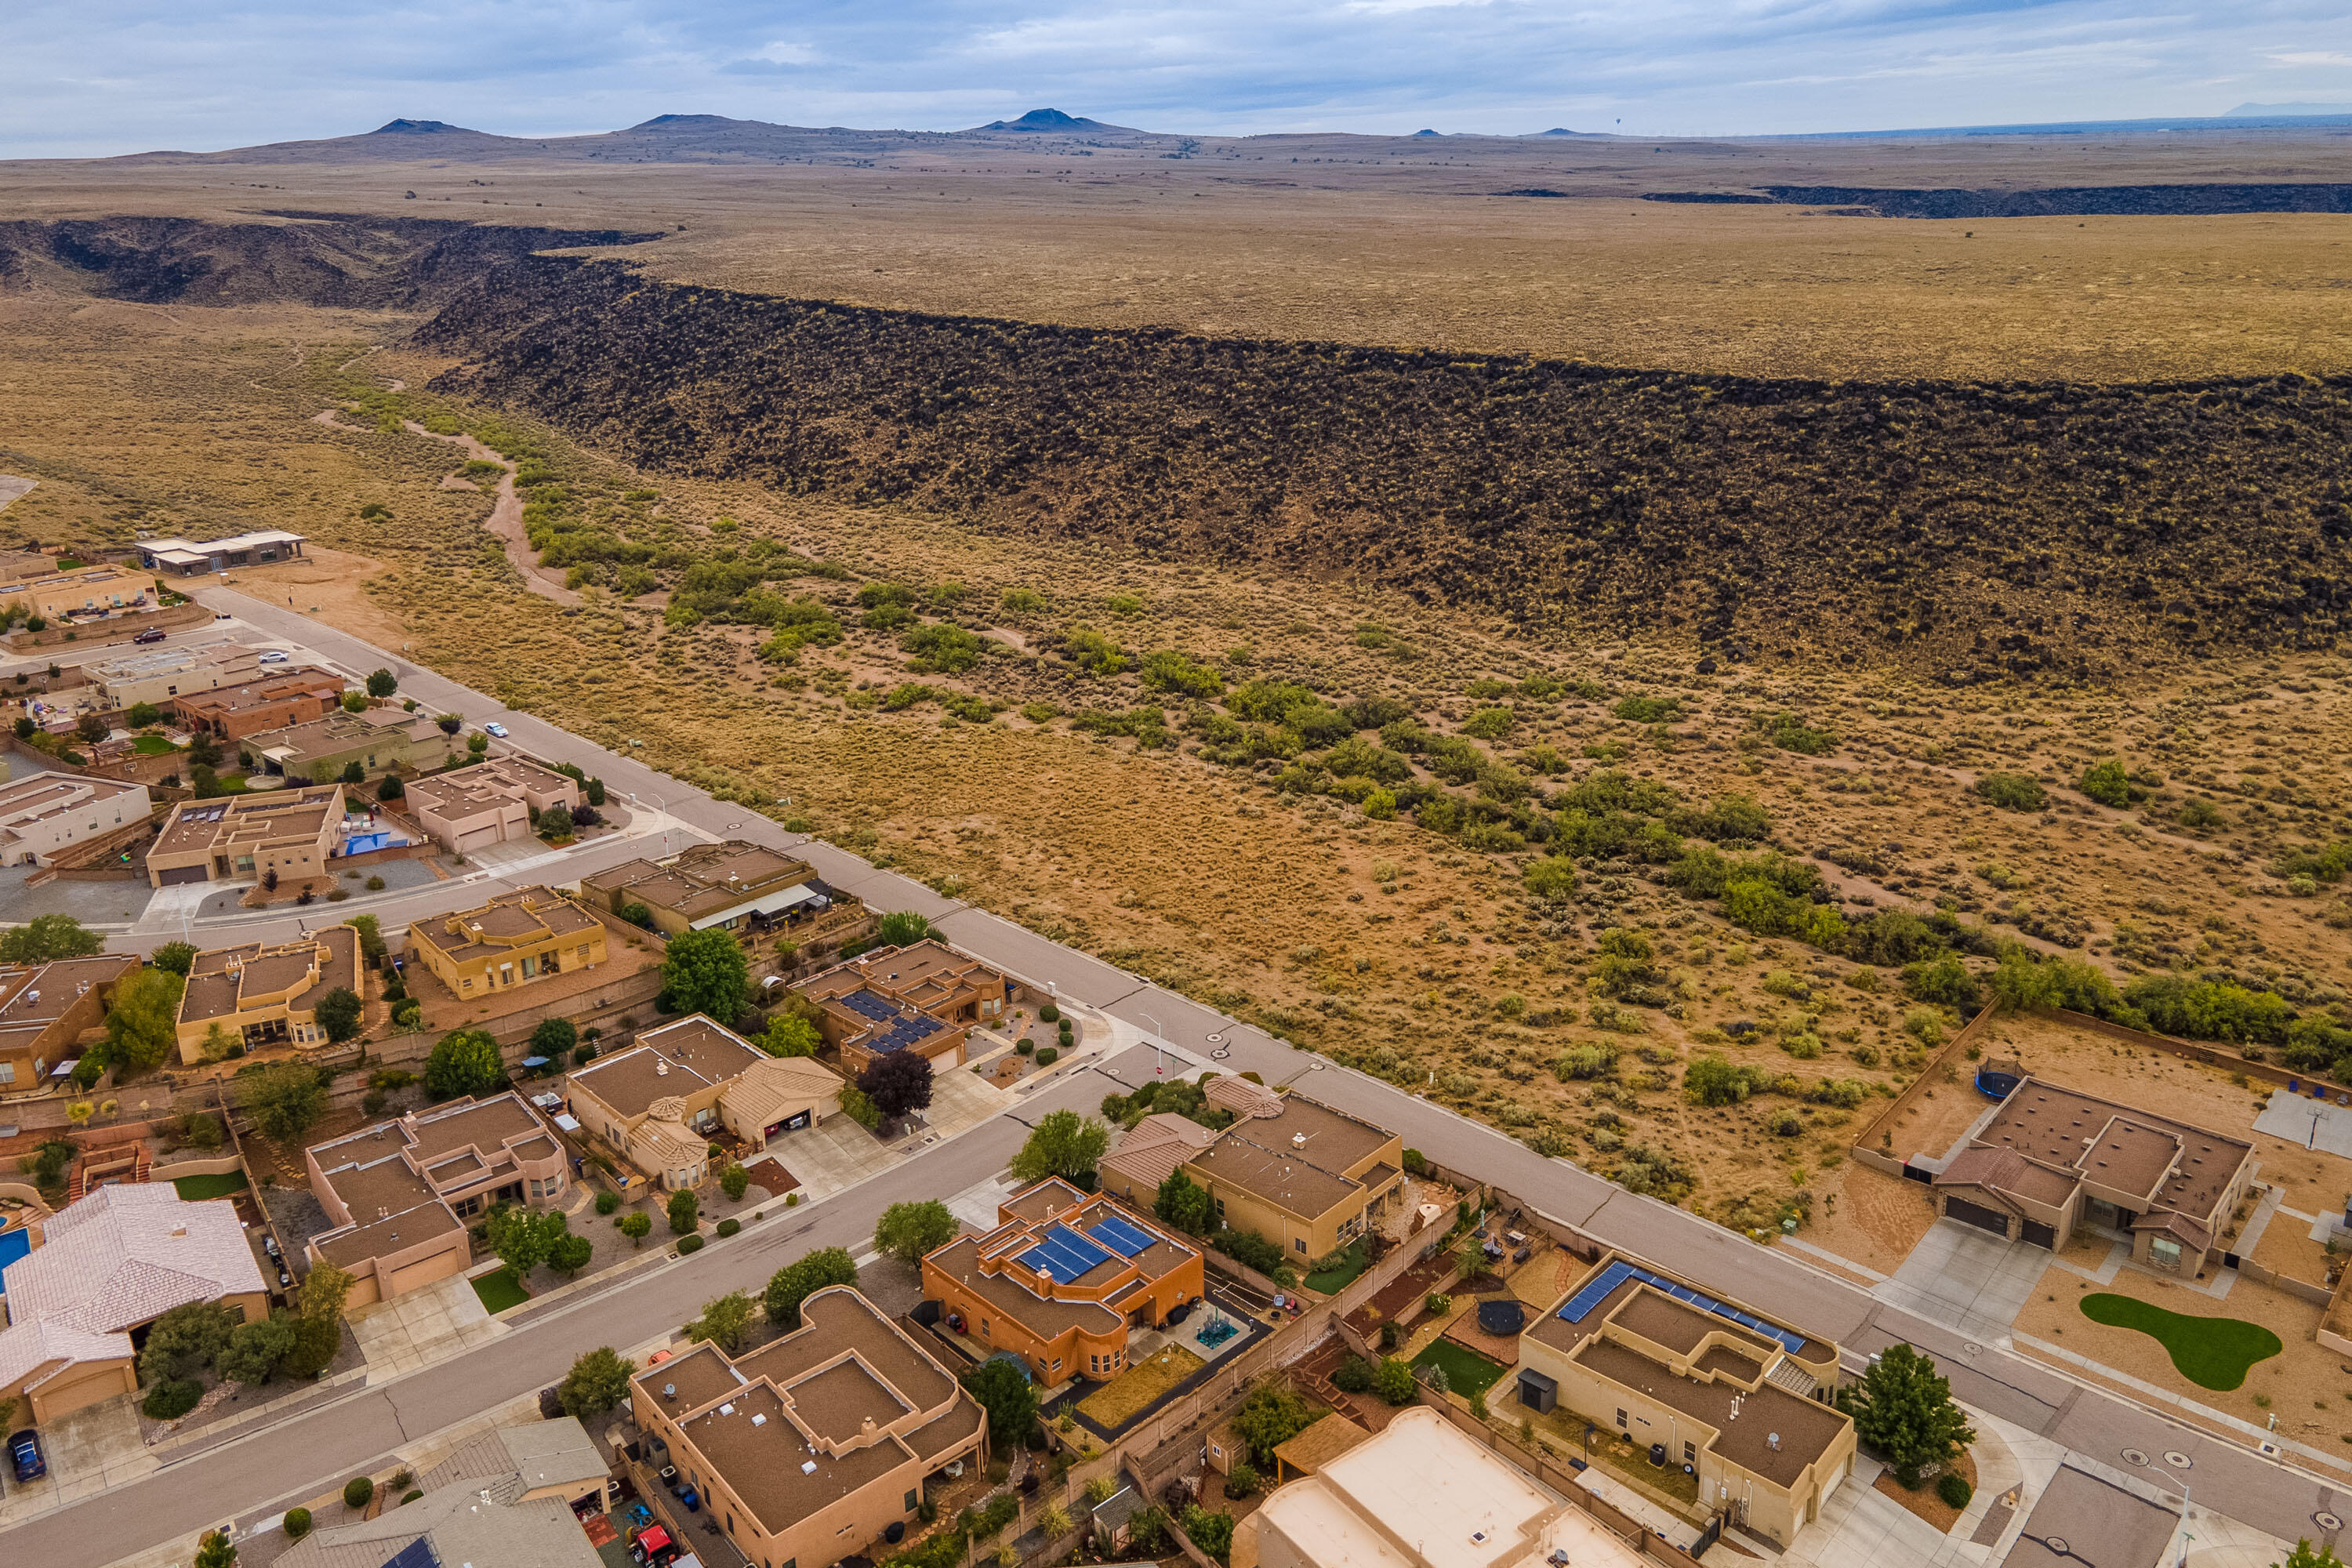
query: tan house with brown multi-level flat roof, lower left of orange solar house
630 1286 988 1568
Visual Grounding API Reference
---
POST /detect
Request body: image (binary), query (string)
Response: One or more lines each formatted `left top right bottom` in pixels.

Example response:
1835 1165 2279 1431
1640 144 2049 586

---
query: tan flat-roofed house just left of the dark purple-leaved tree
569 1013 842 1189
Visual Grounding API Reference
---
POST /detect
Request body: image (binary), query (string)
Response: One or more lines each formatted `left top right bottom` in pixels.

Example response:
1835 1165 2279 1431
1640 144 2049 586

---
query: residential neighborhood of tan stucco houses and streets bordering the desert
0 601 2352 1568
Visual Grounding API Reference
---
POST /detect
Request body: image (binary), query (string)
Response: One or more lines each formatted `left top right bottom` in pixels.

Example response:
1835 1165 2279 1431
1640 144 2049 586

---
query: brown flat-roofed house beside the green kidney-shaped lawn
1933 1076 2253 1276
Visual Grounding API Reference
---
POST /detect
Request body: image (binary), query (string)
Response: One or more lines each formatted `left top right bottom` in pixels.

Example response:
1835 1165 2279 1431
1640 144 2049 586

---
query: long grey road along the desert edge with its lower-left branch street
18 588 2352 1563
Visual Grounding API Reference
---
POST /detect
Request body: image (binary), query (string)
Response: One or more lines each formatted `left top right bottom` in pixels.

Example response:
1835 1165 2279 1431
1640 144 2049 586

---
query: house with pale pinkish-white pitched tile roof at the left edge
0 1182 270 1422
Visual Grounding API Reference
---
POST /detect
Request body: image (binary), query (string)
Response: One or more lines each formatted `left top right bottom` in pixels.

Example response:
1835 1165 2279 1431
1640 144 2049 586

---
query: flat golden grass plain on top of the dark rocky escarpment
13 132 2352 381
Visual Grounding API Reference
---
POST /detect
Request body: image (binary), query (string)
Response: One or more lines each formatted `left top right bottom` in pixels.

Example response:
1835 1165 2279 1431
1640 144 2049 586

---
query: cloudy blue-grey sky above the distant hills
0 0 2352 158
